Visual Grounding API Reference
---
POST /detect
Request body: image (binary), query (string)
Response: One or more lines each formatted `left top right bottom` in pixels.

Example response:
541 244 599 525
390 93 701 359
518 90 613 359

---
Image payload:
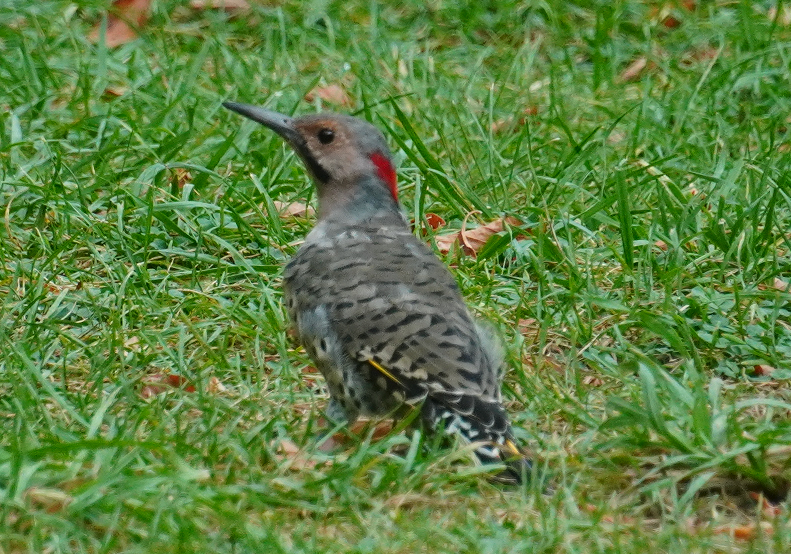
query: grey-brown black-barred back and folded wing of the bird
286 222 499 402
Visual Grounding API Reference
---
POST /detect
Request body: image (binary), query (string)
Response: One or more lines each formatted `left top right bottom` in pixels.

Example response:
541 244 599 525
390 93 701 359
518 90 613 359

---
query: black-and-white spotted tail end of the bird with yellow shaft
422 392 532 484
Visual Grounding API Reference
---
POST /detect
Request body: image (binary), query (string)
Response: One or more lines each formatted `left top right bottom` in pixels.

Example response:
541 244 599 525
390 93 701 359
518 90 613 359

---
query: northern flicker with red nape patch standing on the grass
223 102 530 482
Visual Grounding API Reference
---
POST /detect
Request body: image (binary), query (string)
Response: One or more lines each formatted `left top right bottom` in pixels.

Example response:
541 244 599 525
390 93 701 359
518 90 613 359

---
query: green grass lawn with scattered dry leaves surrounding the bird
0 0 791 554
